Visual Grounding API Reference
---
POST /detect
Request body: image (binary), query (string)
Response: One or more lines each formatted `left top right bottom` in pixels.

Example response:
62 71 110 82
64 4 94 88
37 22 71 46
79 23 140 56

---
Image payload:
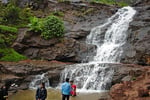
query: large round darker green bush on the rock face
41 15 64 39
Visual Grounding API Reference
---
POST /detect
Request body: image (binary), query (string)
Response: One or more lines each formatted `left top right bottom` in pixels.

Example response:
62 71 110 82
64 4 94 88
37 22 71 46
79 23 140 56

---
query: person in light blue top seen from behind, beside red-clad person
61 78 71 100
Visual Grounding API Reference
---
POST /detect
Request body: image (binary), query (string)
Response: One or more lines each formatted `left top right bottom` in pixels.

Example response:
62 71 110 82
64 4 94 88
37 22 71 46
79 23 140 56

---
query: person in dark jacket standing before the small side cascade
36 83 47 100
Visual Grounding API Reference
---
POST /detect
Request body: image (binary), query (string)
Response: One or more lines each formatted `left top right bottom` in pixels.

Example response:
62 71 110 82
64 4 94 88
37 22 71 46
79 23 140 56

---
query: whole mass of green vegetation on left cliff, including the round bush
0 0 64 61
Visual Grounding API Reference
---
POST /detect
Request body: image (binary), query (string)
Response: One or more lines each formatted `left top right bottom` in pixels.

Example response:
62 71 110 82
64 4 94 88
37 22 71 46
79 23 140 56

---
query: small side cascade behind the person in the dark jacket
29 73 50 89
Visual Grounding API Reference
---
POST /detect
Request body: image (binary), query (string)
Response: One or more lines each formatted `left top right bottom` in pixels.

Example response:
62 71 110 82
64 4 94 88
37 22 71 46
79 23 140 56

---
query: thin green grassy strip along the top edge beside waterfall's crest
91 0 128 7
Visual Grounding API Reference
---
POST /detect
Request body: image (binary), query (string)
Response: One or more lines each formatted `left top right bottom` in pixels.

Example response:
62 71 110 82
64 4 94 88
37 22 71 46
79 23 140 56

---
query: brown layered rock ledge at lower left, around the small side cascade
0 60 71 92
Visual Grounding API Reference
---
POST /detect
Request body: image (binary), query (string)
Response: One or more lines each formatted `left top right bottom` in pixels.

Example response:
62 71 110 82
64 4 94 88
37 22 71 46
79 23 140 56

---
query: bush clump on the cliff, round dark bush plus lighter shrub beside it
28 15 64 39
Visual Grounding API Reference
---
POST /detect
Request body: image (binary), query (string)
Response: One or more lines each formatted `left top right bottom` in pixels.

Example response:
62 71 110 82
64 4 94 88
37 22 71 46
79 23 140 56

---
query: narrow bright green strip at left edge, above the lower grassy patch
0 25 18 33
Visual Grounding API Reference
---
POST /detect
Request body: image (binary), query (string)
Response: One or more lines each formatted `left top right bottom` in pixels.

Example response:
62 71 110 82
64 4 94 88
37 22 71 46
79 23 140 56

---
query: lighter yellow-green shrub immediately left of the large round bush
28 17 42 32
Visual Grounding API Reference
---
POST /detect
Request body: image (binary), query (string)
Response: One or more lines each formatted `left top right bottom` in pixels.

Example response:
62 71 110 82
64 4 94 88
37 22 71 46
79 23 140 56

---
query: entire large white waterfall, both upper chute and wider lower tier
61 7 136 91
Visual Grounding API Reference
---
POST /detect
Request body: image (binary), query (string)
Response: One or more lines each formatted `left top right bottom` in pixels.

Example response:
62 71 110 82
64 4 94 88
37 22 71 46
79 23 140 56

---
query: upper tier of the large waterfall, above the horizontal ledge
87 7 136 63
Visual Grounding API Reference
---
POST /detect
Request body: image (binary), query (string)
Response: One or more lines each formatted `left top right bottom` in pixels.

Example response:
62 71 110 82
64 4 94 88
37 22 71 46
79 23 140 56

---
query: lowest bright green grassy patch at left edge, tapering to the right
0 48 27 61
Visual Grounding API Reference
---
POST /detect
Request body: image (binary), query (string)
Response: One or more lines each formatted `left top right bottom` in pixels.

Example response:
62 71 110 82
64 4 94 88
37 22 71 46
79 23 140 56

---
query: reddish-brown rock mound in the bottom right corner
110 67 150 100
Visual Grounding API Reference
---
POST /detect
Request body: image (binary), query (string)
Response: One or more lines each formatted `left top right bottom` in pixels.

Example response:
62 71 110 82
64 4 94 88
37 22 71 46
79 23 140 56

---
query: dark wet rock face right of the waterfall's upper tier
121 1 150 65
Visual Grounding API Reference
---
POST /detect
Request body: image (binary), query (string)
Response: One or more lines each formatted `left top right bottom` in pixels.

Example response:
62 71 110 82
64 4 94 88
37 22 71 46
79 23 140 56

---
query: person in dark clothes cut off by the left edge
0 85 8 100
